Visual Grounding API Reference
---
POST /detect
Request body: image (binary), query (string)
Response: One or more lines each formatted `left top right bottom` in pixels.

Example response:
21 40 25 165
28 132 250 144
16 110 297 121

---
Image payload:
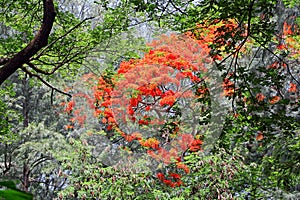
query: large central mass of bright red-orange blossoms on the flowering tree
62 23 234 187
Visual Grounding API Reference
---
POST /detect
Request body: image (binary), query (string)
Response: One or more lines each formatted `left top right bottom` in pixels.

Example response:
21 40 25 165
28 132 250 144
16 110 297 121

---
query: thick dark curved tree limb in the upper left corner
0 0 56 85
